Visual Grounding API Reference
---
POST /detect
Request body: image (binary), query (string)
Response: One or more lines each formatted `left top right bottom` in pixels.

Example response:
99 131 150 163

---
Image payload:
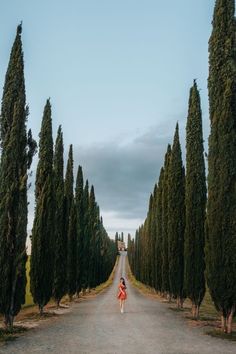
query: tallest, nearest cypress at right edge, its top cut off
206 0 236 333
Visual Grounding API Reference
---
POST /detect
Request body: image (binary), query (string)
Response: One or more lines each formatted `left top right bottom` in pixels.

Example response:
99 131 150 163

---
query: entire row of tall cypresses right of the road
128 0 236 333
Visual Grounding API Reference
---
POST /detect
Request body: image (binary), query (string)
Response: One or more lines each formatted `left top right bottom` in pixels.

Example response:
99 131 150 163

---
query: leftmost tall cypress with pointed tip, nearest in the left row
0 25 36 327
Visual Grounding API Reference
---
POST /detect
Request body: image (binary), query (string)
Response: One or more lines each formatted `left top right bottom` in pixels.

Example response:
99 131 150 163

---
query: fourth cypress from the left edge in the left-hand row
64 145 77 300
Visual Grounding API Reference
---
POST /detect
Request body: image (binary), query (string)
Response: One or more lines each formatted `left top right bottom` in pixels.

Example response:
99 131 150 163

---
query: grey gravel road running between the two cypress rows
0 253 236 354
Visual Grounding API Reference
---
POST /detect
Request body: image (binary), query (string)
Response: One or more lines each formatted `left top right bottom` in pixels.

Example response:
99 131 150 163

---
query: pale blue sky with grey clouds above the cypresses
0 0 215 241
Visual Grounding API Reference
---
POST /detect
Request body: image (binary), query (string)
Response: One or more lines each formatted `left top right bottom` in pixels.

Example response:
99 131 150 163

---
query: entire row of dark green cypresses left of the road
0 25 117 327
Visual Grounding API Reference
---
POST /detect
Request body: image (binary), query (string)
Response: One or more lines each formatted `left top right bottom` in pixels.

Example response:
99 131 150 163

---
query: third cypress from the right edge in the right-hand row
168 124 185 307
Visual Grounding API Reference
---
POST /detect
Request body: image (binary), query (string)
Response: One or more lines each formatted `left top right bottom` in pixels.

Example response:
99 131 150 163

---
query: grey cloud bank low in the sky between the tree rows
74 126 173 235
